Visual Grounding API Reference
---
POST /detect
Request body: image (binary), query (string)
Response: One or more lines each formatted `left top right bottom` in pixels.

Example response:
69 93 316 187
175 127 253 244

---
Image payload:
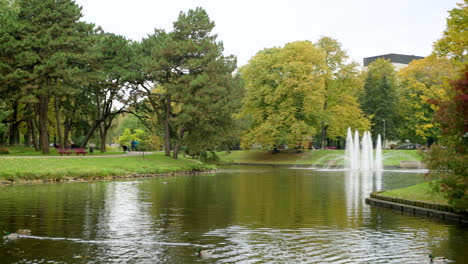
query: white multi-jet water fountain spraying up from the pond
345 128 383 171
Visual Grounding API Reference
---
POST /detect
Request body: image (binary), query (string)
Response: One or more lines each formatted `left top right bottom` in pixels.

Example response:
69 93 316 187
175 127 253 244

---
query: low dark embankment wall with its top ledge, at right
366 192 468 223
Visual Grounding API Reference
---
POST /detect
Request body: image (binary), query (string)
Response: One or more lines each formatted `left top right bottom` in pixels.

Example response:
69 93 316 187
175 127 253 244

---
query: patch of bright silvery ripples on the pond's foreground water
200 226 442 263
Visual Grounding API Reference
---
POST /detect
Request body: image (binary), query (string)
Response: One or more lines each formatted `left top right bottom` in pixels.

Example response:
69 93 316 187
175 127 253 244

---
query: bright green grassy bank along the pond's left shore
0 153 214 182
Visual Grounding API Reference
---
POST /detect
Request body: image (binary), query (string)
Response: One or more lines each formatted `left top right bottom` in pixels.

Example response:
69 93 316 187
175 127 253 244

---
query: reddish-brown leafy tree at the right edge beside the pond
426 66 468 209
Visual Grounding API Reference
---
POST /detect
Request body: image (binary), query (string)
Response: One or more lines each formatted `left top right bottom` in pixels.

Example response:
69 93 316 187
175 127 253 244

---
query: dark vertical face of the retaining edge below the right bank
365 198 468 224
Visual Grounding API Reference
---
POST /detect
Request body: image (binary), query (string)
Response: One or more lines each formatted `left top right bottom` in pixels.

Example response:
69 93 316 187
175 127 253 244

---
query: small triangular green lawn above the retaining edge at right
379 182 448 204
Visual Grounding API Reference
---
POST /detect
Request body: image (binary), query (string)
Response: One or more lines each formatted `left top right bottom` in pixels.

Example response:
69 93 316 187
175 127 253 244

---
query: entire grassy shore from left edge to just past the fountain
0 148 421 184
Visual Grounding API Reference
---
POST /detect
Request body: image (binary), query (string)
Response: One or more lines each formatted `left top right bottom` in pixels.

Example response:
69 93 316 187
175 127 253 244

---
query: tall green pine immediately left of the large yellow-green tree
139 8 238 158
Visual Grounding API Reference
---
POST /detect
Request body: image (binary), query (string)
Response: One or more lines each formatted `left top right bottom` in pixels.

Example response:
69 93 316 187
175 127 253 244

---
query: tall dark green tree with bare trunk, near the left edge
15 0 93 153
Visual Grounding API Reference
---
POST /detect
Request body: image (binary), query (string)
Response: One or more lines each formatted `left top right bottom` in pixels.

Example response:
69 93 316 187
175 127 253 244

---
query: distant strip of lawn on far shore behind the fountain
218 150 421 166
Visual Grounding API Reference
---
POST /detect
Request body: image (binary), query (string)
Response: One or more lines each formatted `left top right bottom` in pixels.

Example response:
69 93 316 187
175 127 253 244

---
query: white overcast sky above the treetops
75 0 462 66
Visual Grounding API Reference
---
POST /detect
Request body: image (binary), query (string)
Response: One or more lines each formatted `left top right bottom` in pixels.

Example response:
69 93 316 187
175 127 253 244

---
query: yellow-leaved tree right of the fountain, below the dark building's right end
398 56 456 143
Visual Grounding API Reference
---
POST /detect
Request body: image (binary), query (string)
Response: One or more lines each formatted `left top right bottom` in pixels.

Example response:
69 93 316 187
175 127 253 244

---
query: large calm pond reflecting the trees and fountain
0 166 468 263
